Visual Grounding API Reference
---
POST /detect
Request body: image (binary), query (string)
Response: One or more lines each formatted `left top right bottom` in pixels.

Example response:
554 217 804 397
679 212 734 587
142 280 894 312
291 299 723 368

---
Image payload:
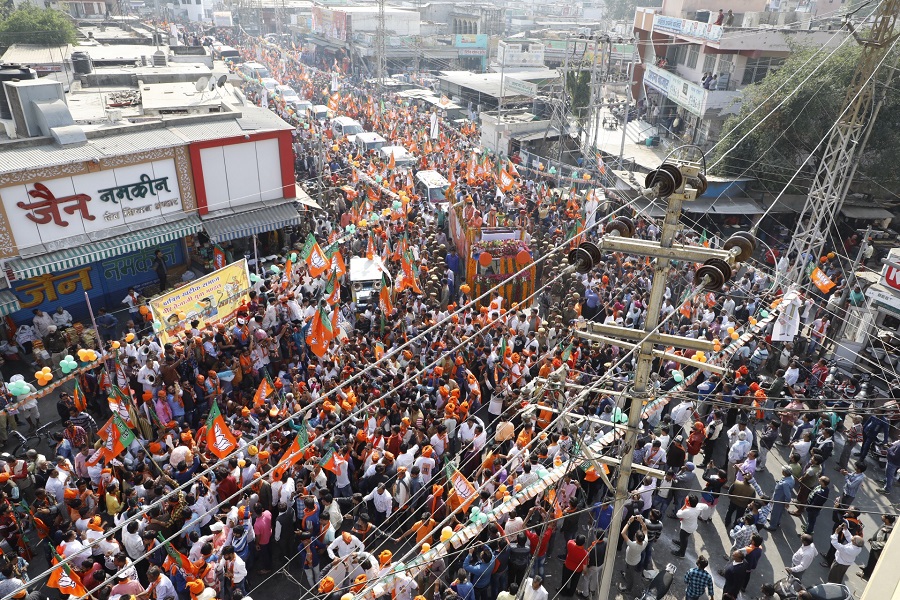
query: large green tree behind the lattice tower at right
712 43 900 196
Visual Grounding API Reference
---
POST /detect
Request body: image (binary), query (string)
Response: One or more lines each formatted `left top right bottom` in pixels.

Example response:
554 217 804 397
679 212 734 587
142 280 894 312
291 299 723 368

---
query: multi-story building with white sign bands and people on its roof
633 0 847 145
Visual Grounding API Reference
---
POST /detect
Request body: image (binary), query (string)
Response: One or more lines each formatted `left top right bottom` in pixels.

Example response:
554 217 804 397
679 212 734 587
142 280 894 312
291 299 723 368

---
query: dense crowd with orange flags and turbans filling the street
0 24 900 600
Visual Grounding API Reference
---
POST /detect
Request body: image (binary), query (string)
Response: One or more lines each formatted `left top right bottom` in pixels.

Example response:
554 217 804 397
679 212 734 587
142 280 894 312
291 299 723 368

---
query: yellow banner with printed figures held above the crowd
150 259 250 343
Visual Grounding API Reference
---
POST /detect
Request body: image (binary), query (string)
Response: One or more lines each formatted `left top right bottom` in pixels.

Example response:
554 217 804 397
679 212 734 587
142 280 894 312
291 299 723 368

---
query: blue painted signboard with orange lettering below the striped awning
12 240 185 324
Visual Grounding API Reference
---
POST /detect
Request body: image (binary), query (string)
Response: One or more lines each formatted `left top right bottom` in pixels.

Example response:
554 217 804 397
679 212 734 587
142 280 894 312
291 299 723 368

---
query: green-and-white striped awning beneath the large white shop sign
6 215 201 279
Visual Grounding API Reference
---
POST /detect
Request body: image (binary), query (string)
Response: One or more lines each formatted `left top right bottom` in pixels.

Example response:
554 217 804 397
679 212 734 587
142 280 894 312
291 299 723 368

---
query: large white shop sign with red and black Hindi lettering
0 158 183 248
